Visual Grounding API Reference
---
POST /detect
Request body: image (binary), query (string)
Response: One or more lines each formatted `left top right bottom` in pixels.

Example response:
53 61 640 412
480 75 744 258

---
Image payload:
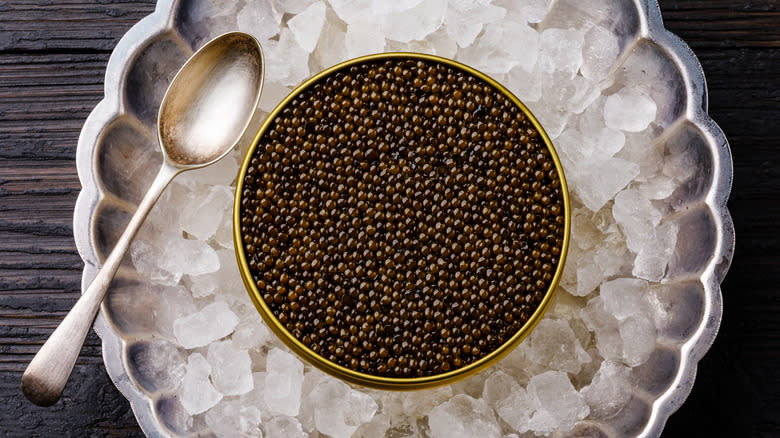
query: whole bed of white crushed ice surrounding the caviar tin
127 0 686 438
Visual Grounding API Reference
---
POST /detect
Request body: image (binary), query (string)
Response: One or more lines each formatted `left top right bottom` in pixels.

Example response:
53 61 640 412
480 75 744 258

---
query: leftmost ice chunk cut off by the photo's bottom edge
205 399 263 438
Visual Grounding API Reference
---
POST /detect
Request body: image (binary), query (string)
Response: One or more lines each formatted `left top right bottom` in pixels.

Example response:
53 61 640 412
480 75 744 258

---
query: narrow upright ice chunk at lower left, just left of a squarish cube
179 353 222 415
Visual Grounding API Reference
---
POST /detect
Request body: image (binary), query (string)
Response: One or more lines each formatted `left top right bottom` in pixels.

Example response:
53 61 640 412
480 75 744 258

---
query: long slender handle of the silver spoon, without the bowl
22 161 181 406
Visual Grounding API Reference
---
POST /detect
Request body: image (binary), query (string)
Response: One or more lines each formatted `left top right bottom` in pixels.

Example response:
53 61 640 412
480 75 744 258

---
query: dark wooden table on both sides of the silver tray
0 0 780 437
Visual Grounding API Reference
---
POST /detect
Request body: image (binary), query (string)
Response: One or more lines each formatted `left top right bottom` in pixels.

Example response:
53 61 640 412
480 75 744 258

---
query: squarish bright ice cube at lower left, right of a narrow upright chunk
206 340 254 395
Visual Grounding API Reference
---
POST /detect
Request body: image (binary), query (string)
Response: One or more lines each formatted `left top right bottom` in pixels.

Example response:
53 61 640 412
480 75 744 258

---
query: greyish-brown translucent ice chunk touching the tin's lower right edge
525 318 590 374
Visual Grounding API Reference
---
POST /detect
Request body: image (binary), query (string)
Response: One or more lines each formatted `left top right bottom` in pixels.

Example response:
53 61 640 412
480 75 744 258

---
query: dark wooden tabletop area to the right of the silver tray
661 0 780 437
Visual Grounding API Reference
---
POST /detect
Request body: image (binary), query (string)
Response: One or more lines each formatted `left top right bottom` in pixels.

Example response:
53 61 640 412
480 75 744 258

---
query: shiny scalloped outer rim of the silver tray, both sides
73 0 735 438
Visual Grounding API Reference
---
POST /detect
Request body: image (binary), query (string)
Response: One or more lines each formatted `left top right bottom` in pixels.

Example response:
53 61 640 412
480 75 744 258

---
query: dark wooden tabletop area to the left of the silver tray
0 0 154 438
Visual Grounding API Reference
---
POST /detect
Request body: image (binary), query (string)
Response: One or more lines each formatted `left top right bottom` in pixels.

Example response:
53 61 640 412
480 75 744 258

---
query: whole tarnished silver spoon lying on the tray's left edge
22 32 265 406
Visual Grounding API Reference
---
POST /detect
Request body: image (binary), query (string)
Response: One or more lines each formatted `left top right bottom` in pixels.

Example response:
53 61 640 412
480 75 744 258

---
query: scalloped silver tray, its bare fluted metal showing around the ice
73 0 734 437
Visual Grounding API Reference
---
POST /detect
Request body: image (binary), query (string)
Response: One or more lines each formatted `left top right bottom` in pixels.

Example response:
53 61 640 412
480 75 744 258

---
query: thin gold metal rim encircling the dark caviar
233 52 571 390
